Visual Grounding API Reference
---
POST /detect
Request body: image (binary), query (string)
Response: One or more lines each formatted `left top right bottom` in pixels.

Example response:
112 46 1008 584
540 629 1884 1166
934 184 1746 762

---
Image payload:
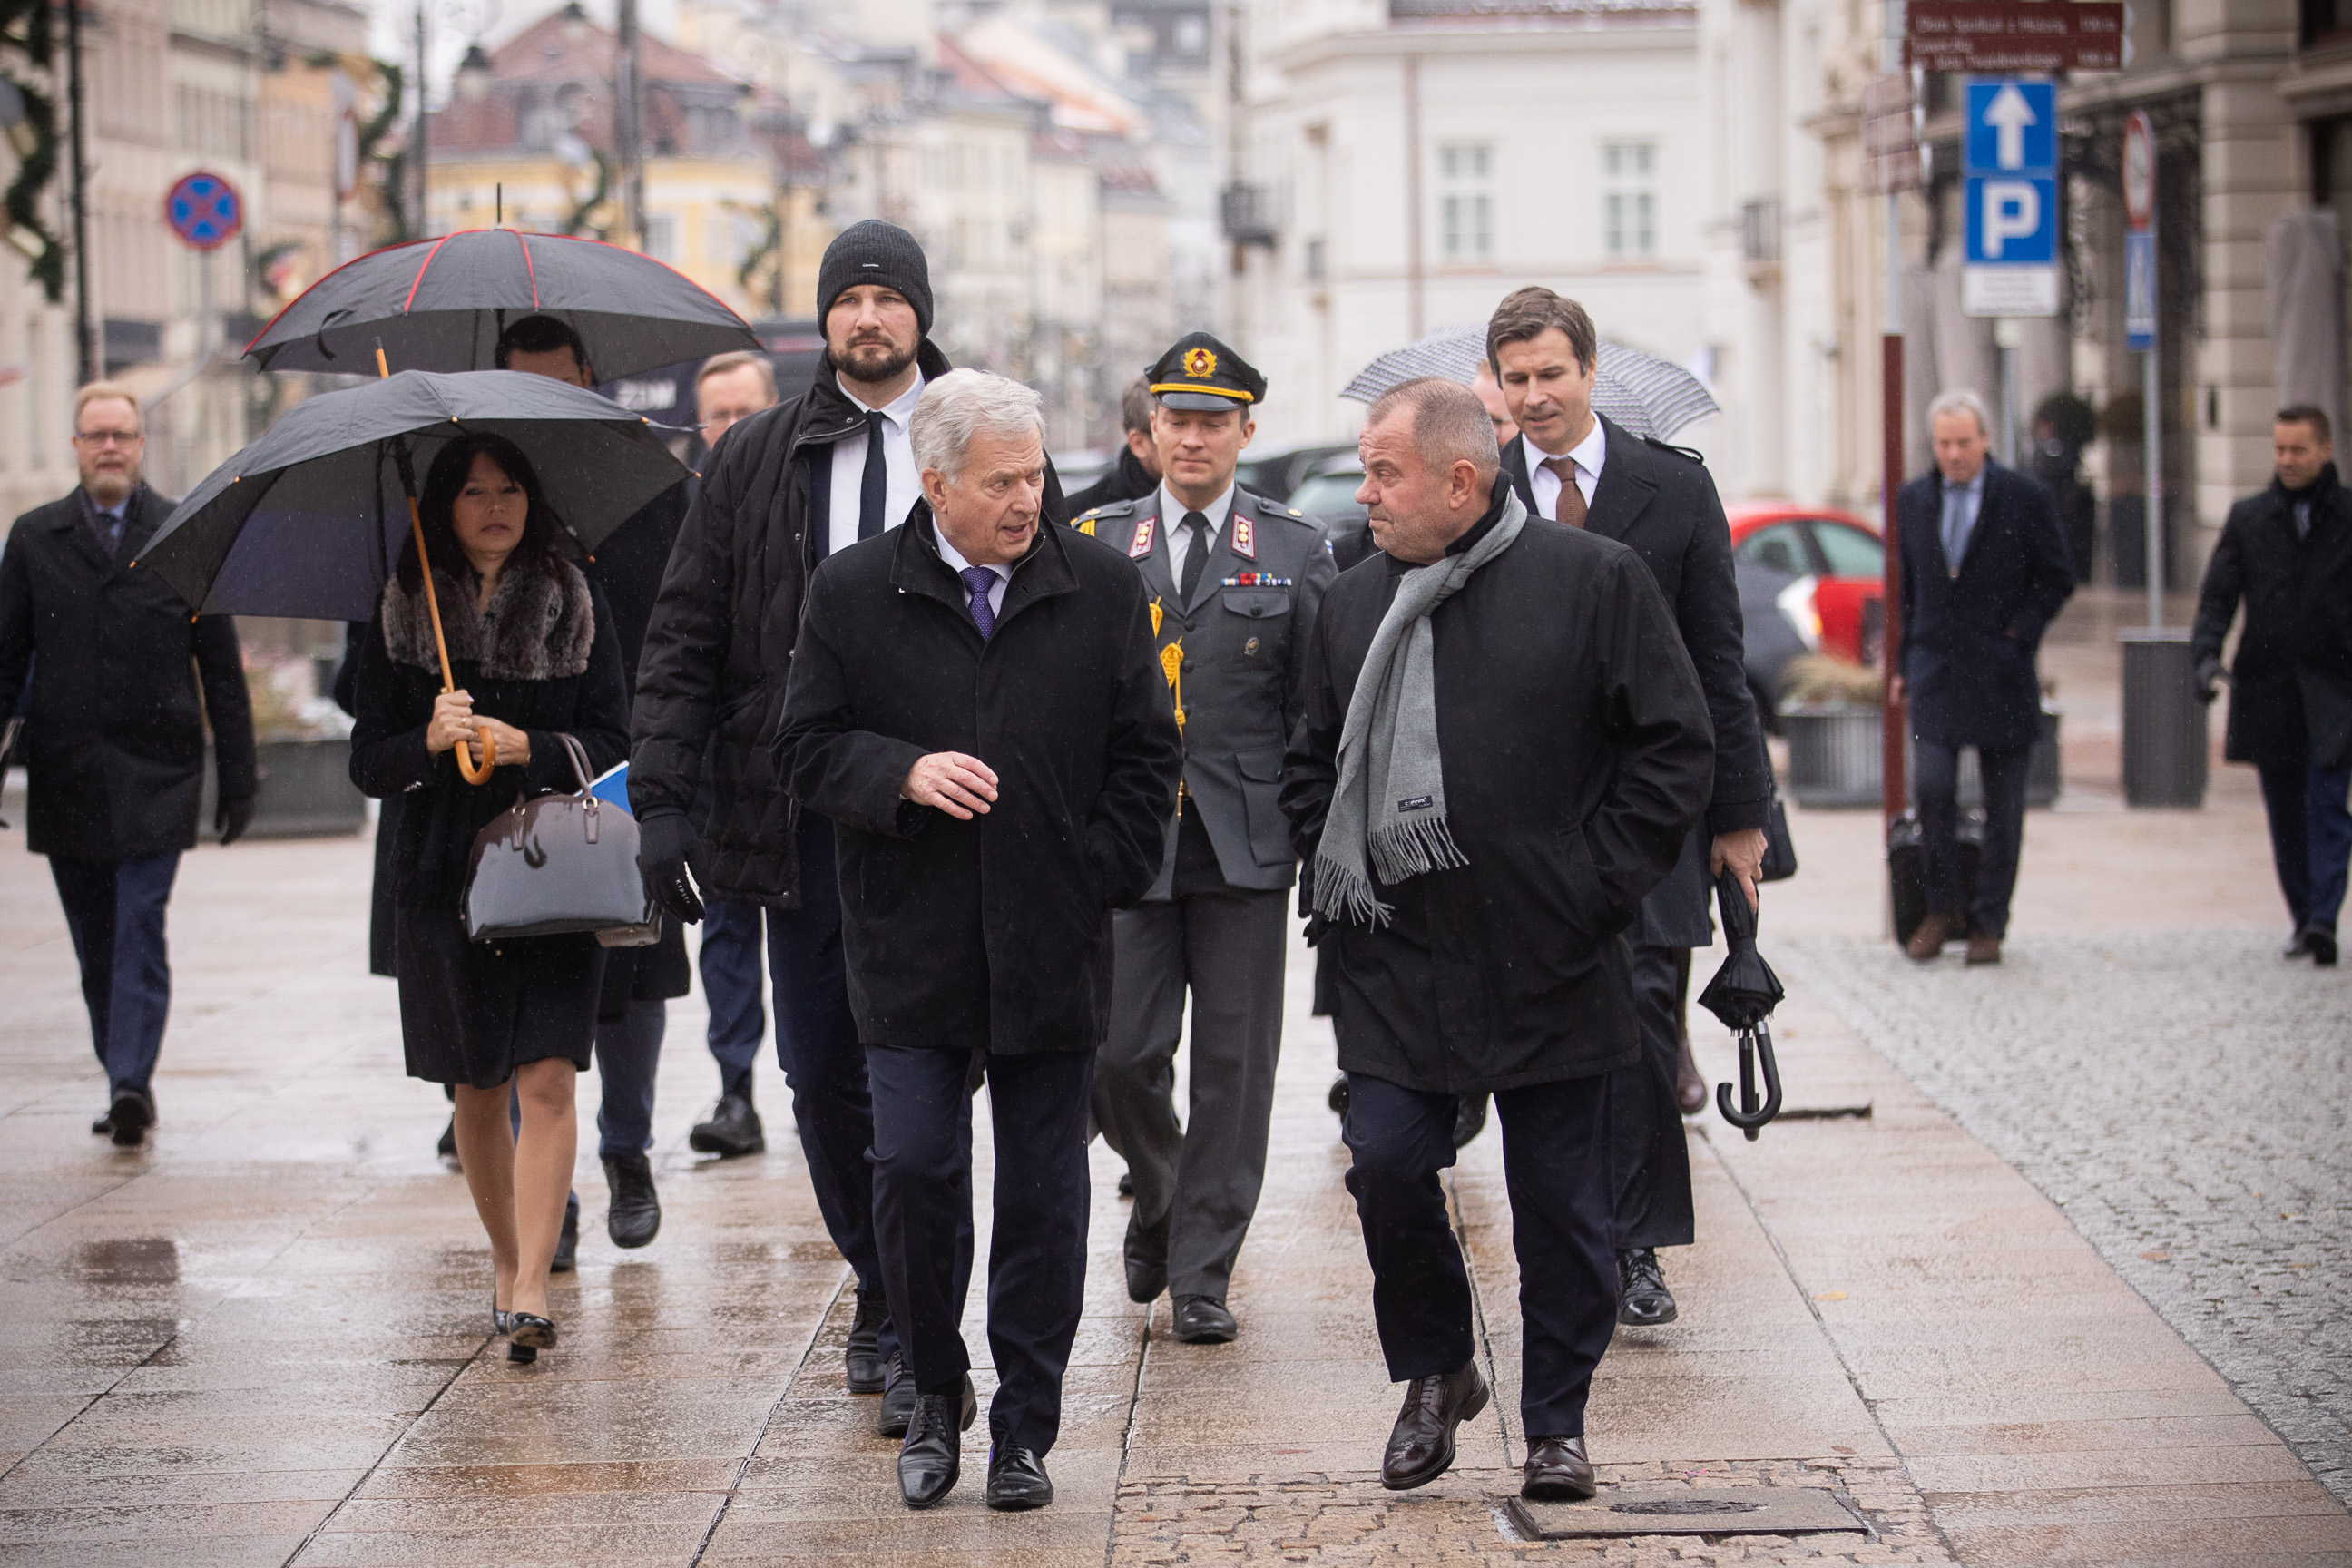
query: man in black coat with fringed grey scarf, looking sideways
1282 378 1715 1500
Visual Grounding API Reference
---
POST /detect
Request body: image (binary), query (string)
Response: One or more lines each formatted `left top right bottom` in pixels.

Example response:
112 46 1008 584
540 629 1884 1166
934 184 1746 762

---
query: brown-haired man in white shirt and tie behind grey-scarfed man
1486 289 1771 1328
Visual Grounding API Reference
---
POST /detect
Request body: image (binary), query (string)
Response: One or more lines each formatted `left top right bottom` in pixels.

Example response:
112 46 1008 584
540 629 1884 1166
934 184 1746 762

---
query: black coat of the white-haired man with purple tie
776 505 1183 1055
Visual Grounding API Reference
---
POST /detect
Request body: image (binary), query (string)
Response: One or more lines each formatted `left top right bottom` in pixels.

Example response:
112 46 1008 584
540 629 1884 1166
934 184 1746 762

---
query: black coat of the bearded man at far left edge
0 485 257 863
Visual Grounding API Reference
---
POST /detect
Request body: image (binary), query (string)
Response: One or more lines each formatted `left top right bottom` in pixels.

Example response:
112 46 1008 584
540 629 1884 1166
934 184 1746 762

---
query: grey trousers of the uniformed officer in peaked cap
1093 888 1289 1300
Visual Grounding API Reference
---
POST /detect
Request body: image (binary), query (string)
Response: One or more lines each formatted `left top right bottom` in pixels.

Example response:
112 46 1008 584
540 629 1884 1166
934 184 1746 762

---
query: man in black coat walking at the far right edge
2190 405 2352 966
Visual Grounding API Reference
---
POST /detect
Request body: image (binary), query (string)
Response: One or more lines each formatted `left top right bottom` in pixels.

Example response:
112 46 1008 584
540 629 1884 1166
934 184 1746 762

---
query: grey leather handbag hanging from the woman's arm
458 736 661 947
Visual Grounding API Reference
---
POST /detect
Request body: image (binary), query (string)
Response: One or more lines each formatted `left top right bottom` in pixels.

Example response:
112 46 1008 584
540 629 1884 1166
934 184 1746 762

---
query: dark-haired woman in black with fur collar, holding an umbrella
350 435 628 1361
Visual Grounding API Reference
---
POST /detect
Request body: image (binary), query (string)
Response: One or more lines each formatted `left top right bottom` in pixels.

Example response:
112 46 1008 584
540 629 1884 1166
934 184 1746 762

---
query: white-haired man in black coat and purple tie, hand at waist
776 369 1181 1509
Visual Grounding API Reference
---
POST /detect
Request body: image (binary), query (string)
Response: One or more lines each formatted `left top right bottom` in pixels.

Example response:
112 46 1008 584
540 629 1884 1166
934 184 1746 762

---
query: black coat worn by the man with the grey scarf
1282 503 1715 1093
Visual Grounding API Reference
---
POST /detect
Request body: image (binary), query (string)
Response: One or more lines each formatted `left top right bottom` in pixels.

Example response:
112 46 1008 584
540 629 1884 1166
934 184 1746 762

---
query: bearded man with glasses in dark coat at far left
0 381 257 1147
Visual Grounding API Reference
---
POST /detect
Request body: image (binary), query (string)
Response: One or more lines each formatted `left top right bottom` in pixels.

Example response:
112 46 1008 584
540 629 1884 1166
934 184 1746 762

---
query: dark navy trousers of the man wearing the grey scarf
1346 1072 1618 1436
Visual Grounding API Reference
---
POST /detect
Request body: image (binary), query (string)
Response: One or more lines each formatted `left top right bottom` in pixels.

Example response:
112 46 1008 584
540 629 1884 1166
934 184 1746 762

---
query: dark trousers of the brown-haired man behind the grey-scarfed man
1609 943 1698 1249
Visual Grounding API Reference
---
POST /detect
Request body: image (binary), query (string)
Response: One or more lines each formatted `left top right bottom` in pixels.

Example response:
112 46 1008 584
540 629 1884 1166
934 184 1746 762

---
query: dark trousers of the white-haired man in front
866 1046 1093 1455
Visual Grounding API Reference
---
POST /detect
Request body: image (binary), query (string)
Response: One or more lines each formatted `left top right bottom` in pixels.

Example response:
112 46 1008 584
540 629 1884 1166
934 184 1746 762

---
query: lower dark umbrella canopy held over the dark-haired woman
136 371 687 621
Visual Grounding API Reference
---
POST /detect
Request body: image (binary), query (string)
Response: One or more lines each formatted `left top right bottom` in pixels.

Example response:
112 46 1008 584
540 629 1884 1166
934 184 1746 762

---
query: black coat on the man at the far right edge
2192 463 2352 769
